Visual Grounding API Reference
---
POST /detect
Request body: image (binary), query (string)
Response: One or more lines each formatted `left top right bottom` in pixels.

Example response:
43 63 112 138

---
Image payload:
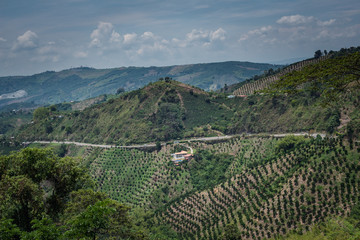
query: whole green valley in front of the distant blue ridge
0 49 360 240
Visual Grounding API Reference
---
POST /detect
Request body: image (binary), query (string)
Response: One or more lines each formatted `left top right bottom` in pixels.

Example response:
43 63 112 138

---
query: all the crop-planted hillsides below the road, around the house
85 137 360 239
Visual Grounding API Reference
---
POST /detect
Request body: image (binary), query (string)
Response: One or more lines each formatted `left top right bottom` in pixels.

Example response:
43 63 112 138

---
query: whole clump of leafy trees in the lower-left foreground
0 148 153 240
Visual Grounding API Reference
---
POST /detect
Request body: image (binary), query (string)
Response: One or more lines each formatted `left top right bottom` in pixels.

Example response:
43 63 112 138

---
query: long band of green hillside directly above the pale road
17 78 359 145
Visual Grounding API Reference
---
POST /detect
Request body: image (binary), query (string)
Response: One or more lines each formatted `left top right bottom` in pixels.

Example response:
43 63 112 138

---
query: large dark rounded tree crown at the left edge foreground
0 148 90 231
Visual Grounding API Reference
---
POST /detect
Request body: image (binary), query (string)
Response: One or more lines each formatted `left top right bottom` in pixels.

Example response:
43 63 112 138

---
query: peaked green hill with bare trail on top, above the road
19 81 232 144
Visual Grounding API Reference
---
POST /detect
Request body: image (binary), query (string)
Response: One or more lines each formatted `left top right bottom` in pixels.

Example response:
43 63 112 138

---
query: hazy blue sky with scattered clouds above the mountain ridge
0 0 360 76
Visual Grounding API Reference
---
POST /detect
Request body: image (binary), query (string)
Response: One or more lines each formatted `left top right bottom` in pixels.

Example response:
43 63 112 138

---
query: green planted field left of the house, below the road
91 148 168 205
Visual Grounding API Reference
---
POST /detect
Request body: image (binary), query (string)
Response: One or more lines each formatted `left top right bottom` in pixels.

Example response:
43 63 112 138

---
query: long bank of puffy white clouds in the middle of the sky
85 22 227 62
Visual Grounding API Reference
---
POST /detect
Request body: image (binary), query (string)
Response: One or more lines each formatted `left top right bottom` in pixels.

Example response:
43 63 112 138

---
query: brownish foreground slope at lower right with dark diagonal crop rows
157 139 360 239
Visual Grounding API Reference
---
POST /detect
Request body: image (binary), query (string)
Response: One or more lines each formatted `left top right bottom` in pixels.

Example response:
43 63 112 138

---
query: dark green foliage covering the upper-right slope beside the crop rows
266 52 360 104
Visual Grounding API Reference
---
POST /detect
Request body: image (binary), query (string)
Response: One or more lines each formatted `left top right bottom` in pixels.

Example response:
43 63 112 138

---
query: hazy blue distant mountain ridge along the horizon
0 61 281 111
